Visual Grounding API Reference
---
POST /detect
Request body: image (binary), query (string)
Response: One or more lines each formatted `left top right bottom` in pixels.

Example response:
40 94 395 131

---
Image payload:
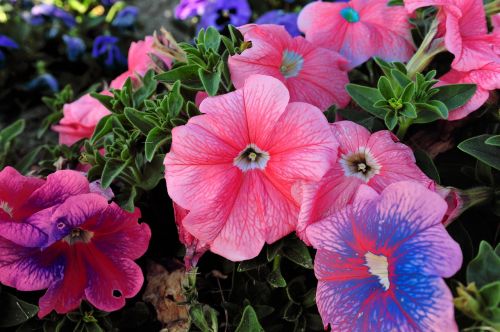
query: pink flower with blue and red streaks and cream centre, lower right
307 181 462 331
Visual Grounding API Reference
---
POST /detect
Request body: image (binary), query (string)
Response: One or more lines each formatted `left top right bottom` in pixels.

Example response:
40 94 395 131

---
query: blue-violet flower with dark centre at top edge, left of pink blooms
198 0 252 31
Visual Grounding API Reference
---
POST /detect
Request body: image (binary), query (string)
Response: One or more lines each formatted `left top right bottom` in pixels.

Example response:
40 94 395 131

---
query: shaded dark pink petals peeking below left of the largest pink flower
173 202 208 270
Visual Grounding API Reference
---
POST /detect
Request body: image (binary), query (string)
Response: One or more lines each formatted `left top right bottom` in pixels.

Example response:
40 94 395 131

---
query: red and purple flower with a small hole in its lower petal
0 193 151 318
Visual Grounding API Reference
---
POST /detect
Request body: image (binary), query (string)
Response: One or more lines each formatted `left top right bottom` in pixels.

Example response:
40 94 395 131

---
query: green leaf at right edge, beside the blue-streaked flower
467 241 500 288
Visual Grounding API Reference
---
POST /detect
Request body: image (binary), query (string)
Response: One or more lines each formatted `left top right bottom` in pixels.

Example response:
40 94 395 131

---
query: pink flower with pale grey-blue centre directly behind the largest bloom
229 24 350 110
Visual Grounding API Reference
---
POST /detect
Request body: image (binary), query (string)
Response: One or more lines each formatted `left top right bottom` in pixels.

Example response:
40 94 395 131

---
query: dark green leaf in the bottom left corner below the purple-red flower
0 292 38 328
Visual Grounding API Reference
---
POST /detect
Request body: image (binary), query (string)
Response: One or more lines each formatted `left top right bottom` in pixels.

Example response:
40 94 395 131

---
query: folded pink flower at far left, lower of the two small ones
52 91 111 145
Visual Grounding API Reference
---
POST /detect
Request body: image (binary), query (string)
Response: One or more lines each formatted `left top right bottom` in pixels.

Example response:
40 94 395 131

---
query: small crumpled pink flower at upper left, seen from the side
110 36 172 89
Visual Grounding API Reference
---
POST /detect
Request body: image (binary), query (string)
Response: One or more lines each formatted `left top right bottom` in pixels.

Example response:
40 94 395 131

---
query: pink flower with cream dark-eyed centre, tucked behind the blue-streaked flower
297 121 434 243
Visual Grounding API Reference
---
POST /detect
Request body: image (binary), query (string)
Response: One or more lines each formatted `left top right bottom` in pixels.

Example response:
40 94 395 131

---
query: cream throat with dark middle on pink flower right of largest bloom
340 147 381 182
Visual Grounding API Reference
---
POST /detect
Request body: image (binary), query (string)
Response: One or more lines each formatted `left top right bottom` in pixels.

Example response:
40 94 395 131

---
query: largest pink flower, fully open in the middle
165 75 337 261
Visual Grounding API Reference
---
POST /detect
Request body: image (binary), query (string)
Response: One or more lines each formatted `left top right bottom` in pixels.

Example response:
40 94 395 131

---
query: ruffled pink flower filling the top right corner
405 0 500 71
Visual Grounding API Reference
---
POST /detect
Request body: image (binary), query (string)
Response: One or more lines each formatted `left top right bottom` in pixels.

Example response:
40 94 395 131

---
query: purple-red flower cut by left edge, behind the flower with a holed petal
0 167 90 248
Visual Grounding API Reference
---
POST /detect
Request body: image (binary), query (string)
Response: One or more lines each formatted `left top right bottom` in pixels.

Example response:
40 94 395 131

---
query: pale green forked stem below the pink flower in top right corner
406 19 445 79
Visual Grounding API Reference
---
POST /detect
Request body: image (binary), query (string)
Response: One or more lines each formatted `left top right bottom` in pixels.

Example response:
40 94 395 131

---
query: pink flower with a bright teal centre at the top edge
298 0 415 68
